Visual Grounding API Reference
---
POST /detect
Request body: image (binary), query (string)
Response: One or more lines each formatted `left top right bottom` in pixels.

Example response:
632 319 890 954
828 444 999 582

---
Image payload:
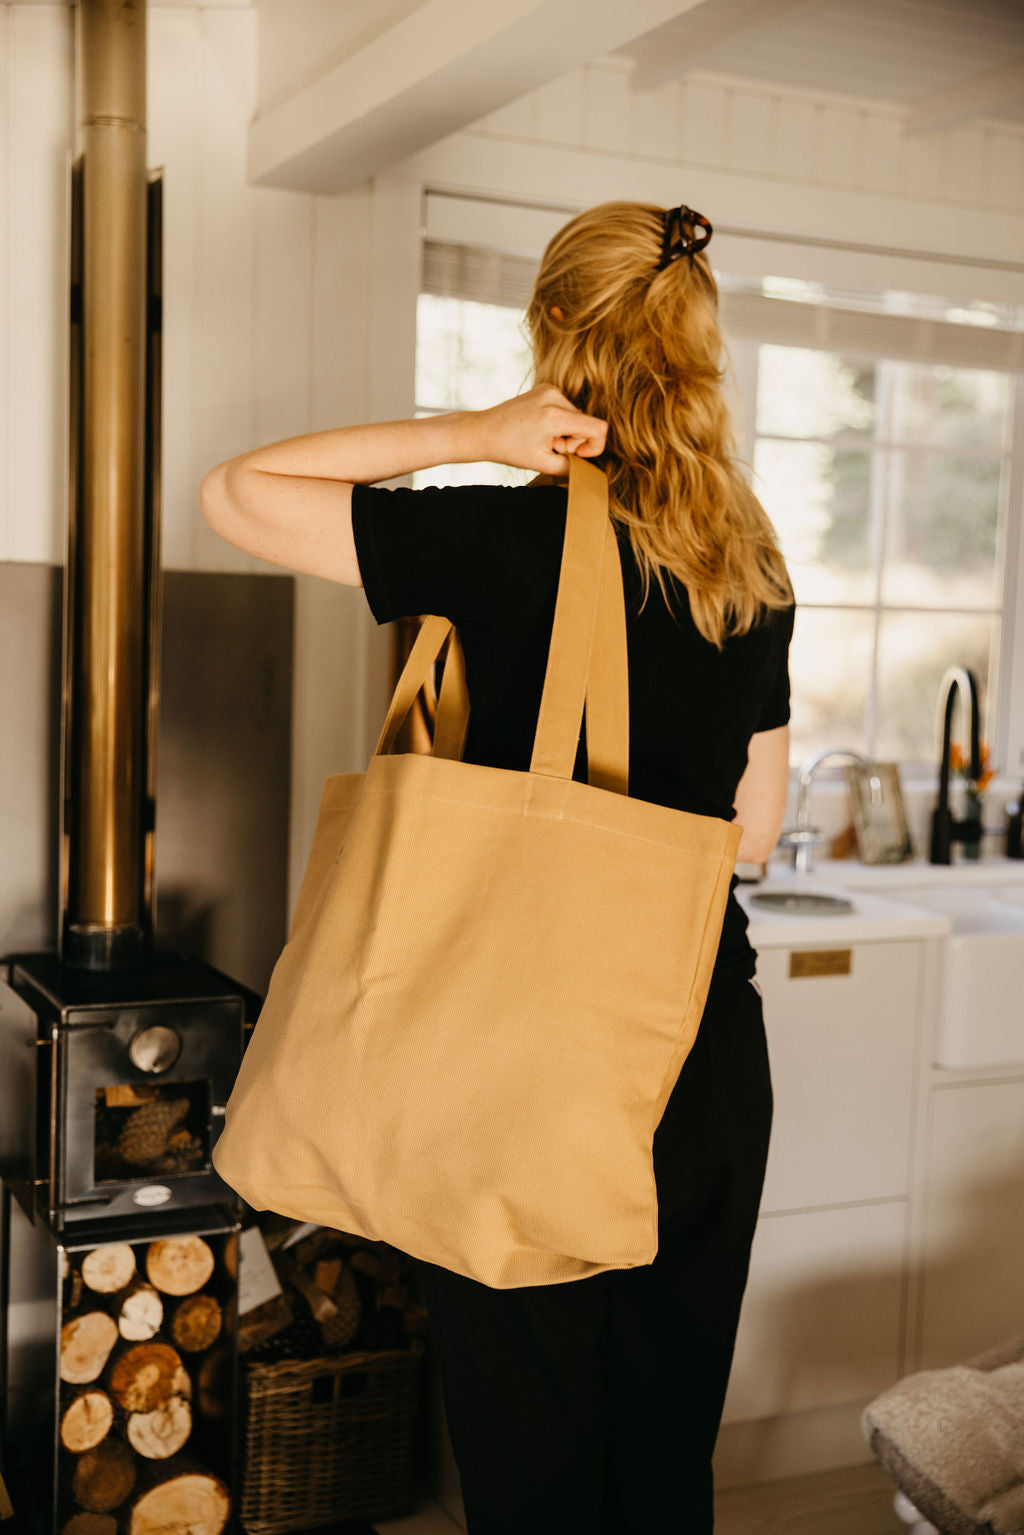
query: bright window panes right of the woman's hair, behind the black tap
754 345 1013 764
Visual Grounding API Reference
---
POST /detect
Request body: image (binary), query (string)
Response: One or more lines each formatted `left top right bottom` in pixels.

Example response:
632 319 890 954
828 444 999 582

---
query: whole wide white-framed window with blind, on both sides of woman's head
415 241 1024 771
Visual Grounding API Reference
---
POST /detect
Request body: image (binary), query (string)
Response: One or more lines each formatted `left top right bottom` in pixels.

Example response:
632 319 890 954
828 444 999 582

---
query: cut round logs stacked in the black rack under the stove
58 1236 232 1535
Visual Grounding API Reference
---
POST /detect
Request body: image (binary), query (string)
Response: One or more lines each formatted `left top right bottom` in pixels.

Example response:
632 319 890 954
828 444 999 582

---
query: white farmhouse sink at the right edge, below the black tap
894 886 1024 1067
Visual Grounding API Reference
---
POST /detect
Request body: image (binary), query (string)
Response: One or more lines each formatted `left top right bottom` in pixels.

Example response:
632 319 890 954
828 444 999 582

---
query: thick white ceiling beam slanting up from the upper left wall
249 0 700 192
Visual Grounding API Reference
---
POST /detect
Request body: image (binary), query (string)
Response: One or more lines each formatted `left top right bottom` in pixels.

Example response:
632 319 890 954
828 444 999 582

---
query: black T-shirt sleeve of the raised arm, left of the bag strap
352 485 567 625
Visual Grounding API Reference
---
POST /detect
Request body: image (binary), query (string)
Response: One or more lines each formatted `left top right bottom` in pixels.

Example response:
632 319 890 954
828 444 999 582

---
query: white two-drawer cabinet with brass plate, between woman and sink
723 939 923 1449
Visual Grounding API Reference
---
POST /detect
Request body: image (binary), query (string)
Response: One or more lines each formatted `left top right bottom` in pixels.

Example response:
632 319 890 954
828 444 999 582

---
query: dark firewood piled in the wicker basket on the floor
238 1216 428 1363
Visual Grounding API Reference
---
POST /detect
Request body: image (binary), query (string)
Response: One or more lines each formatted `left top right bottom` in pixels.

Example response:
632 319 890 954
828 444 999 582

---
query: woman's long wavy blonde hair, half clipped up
527 203 794 649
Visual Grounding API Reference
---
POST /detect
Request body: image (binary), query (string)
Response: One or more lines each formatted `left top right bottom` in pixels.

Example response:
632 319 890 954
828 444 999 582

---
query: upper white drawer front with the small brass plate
757 941 921 1213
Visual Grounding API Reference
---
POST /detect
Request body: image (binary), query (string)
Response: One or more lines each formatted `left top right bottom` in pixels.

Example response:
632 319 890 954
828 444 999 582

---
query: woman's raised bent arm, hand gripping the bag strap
200 384 606 586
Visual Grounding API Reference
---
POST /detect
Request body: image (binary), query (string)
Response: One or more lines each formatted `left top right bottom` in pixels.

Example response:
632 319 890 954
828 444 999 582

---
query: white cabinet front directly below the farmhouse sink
917 1079 1024 1369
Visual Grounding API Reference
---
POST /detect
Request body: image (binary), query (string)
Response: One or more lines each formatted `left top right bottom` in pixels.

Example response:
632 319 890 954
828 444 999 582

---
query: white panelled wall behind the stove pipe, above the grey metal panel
0 5 330 573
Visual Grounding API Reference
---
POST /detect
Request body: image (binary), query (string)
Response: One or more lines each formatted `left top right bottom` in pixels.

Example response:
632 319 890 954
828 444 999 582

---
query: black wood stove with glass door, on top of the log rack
0 952 258 1233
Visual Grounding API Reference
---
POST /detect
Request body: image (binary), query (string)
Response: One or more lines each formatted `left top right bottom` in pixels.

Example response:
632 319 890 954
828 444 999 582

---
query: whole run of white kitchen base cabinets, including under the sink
715 869 1024 1486
